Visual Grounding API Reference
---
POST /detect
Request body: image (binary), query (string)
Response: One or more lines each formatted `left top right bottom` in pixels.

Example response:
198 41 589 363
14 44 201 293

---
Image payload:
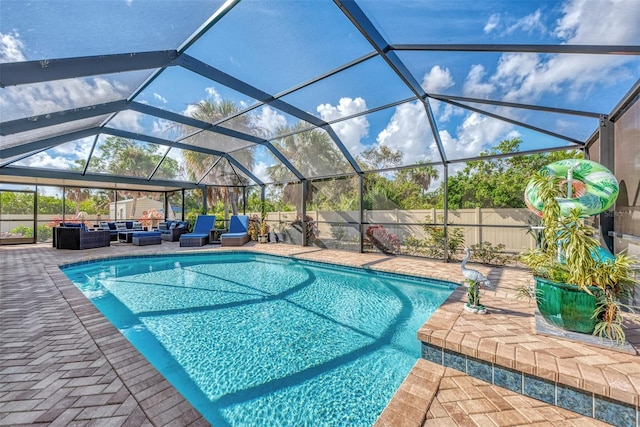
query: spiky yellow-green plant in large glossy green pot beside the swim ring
521 169 637 343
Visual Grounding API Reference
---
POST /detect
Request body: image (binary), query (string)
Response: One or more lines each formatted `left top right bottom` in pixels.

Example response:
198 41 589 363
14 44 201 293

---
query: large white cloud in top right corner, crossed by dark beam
464 0 640 107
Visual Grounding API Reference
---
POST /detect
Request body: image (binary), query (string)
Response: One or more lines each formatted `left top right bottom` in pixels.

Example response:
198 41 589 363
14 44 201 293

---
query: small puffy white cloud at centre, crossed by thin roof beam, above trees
317 98 369 156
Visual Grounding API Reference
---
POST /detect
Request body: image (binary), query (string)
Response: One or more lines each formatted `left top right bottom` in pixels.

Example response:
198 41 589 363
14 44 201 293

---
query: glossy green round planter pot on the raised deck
535 277 597 334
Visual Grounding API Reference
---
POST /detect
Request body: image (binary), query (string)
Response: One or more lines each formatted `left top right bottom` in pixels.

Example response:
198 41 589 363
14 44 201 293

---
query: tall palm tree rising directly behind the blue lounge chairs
183 100 259 219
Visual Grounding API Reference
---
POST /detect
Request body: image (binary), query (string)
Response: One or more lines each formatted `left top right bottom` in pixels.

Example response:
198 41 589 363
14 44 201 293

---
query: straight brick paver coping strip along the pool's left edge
44 265 210 426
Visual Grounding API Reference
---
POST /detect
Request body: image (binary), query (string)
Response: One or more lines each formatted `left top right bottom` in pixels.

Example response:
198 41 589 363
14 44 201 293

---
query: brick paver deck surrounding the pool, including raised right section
0 242 640 427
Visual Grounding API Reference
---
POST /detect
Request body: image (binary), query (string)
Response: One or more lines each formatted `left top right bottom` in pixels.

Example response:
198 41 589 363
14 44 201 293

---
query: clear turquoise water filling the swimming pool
62 252 455 426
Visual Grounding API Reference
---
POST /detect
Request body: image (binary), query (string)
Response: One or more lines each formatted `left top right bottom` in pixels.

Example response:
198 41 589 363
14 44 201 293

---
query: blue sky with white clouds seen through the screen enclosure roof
0 0 640 186
